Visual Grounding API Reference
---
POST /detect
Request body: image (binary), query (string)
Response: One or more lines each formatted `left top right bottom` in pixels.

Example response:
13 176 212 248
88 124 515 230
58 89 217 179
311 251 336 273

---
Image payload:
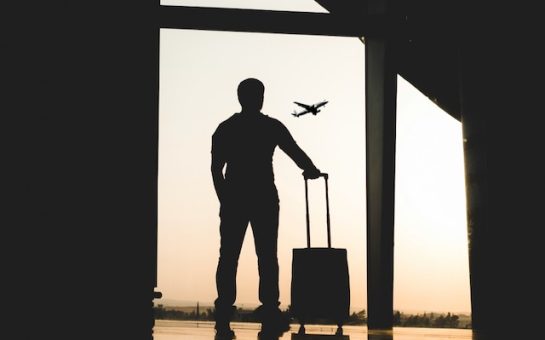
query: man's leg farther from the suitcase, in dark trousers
214 212 248 338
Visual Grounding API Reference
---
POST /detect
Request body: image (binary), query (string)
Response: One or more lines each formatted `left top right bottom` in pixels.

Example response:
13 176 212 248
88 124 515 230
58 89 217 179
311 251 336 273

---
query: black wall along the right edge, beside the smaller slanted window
460 6 545 339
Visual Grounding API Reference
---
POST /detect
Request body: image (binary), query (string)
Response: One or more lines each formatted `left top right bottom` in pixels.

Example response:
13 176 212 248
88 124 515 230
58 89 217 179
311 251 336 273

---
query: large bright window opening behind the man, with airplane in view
156 29 366 317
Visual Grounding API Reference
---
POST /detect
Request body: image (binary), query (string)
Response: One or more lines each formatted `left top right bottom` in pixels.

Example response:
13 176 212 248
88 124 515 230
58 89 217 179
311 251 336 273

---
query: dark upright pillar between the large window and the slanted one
365 1 397 329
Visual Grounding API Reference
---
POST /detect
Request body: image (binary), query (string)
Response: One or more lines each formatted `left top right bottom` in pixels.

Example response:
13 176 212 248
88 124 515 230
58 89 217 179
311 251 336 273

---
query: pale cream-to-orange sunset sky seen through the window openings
157 0 470 313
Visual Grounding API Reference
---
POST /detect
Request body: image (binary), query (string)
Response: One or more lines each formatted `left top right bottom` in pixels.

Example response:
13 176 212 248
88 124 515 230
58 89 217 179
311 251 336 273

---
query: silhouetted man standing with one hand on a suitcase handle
211 78 320 339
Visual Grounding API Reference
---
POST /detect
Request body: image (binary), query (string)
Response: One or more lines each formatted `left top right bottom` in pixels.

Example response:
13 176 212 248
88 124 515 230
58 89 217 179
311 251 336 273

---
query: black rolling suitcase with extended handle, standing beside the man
290 174 350 335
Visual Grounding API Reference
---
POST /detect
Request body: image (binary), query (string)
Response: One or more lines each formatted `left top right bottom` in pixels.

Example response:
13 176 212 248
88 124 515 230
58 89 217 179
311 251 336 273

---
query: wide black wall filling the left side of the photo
7 1 158 339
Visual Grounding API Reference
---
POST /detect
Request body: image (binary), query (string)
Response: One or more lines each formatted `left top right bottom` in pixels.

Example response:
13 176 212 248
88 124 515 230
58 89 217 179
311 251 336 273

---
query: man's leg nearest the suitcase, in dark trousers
250 203 289 332
